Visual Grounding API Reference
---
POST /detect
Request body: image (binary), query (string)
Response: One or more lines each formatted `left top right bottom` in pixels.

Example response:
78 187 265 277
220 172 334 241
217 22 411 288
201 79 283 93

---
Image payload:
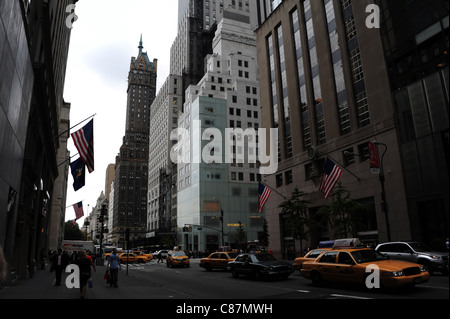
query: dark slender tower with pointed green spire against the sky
112 36 157 246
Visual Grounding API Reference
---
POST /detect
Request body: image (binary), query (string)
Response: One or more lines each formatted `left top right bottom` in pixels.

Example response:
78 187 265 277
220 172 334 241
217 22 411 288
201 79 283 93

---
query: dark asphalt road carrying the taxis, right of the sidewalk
121 259 449 300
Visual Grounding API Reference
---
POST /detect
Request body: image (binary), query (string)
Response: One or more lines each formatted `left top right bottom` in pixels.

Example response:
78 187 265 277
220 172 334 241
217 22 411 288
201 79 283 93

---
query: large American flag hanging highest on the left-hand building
71 119 94 173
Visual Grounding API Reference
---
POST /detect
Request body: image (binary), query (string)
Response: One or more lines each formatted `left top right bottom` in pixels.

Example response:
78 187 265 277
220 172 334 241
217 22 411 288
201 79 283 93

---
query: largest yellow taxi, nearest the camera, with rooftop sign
301 239 430 288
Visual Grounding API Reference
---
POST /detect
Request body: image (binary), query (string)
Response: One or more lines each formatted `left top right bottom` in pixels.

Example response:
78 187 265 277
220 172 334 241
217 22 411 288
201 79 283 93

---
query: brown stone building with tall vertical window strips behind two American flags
257 0 410 257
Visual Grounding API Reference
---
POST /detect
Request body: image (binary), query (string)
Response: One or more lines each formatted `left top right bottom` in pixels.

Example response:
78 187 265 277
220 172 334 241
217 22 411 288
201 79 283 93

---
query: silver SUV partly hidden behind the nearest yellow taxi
375 241 448 274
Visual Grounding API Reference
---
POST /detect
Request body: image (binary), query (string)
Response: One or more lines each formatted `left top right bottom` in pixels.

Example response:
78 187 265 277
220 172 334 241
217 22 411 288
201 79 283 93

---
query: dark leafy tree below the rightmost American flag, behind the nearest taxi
319 182 365 238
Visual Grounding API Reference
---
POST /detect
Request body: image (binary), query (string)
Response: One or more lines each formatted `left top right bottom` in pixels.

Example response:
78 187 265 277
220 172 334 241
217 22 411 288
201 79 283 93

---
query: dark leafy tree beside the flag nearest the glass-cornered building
278 187 311 252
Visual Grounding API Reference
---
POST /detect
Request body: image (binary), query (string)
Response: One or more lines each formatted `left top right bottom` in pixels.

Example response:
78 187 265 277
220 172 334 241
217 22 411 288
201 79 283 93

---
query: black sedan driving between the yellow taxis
228 253 294 280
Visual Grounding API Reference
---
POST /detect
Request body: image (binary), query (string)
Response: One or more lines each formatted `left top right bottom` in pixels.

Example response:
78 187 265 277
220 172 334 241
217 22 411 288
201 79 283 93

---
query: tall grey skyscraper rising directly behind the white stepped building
147 0 256 245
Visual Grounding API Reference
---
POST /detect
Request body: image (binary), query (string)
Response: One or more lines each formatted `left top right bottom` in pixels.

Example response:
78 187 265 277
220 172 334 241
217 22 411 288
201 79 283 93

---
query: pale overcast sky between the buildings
64 0 178 226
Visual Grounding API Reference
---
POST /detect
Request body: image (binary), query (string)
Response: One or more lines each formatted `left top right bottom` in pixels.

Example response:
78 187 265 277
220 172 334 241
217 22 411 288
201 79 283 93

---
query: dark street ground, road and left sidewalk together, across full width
0 259 449 301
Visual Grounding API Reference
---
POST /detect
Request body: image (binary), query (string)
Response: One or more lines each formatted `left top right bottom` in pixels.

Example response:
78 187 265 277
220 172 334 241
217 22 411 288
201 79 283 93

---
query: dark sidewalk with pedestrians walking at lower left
0 266 152 300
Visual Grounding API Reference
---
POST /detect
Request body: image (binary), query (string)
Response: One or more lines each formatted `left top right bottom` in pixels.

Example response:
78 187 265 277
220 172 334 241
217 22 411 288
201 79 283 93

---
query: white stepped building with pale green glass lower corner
174 9 263 251
